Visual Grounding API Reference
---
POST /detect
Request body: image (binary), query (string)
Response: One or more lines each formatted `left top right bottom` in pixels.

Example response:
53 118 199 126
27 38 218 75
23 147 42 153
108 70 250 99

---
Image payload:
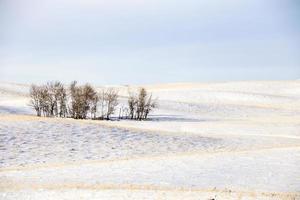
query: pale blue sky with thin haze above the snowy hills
0 0 300 84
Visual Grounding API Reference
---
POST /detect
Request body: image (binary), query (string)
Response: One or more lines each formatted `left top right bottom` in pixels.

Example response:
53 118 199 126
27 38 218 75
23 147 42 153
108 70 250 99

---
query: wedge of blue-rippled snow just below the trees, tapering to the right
0 116 299 167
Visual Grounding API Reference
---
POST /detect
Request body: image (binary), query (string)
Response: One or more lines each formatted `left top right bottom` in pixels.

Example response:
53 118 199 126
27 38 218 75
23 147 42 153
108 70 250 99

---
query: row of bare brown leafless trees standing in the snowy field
29 81 157 120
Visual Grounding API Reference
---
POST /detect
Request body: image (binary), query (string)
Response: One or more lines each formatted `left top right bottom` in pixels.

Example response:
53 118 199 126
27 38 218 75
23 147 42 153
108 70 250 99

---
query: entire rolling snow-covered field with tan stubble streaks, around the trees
0 81 300 199
